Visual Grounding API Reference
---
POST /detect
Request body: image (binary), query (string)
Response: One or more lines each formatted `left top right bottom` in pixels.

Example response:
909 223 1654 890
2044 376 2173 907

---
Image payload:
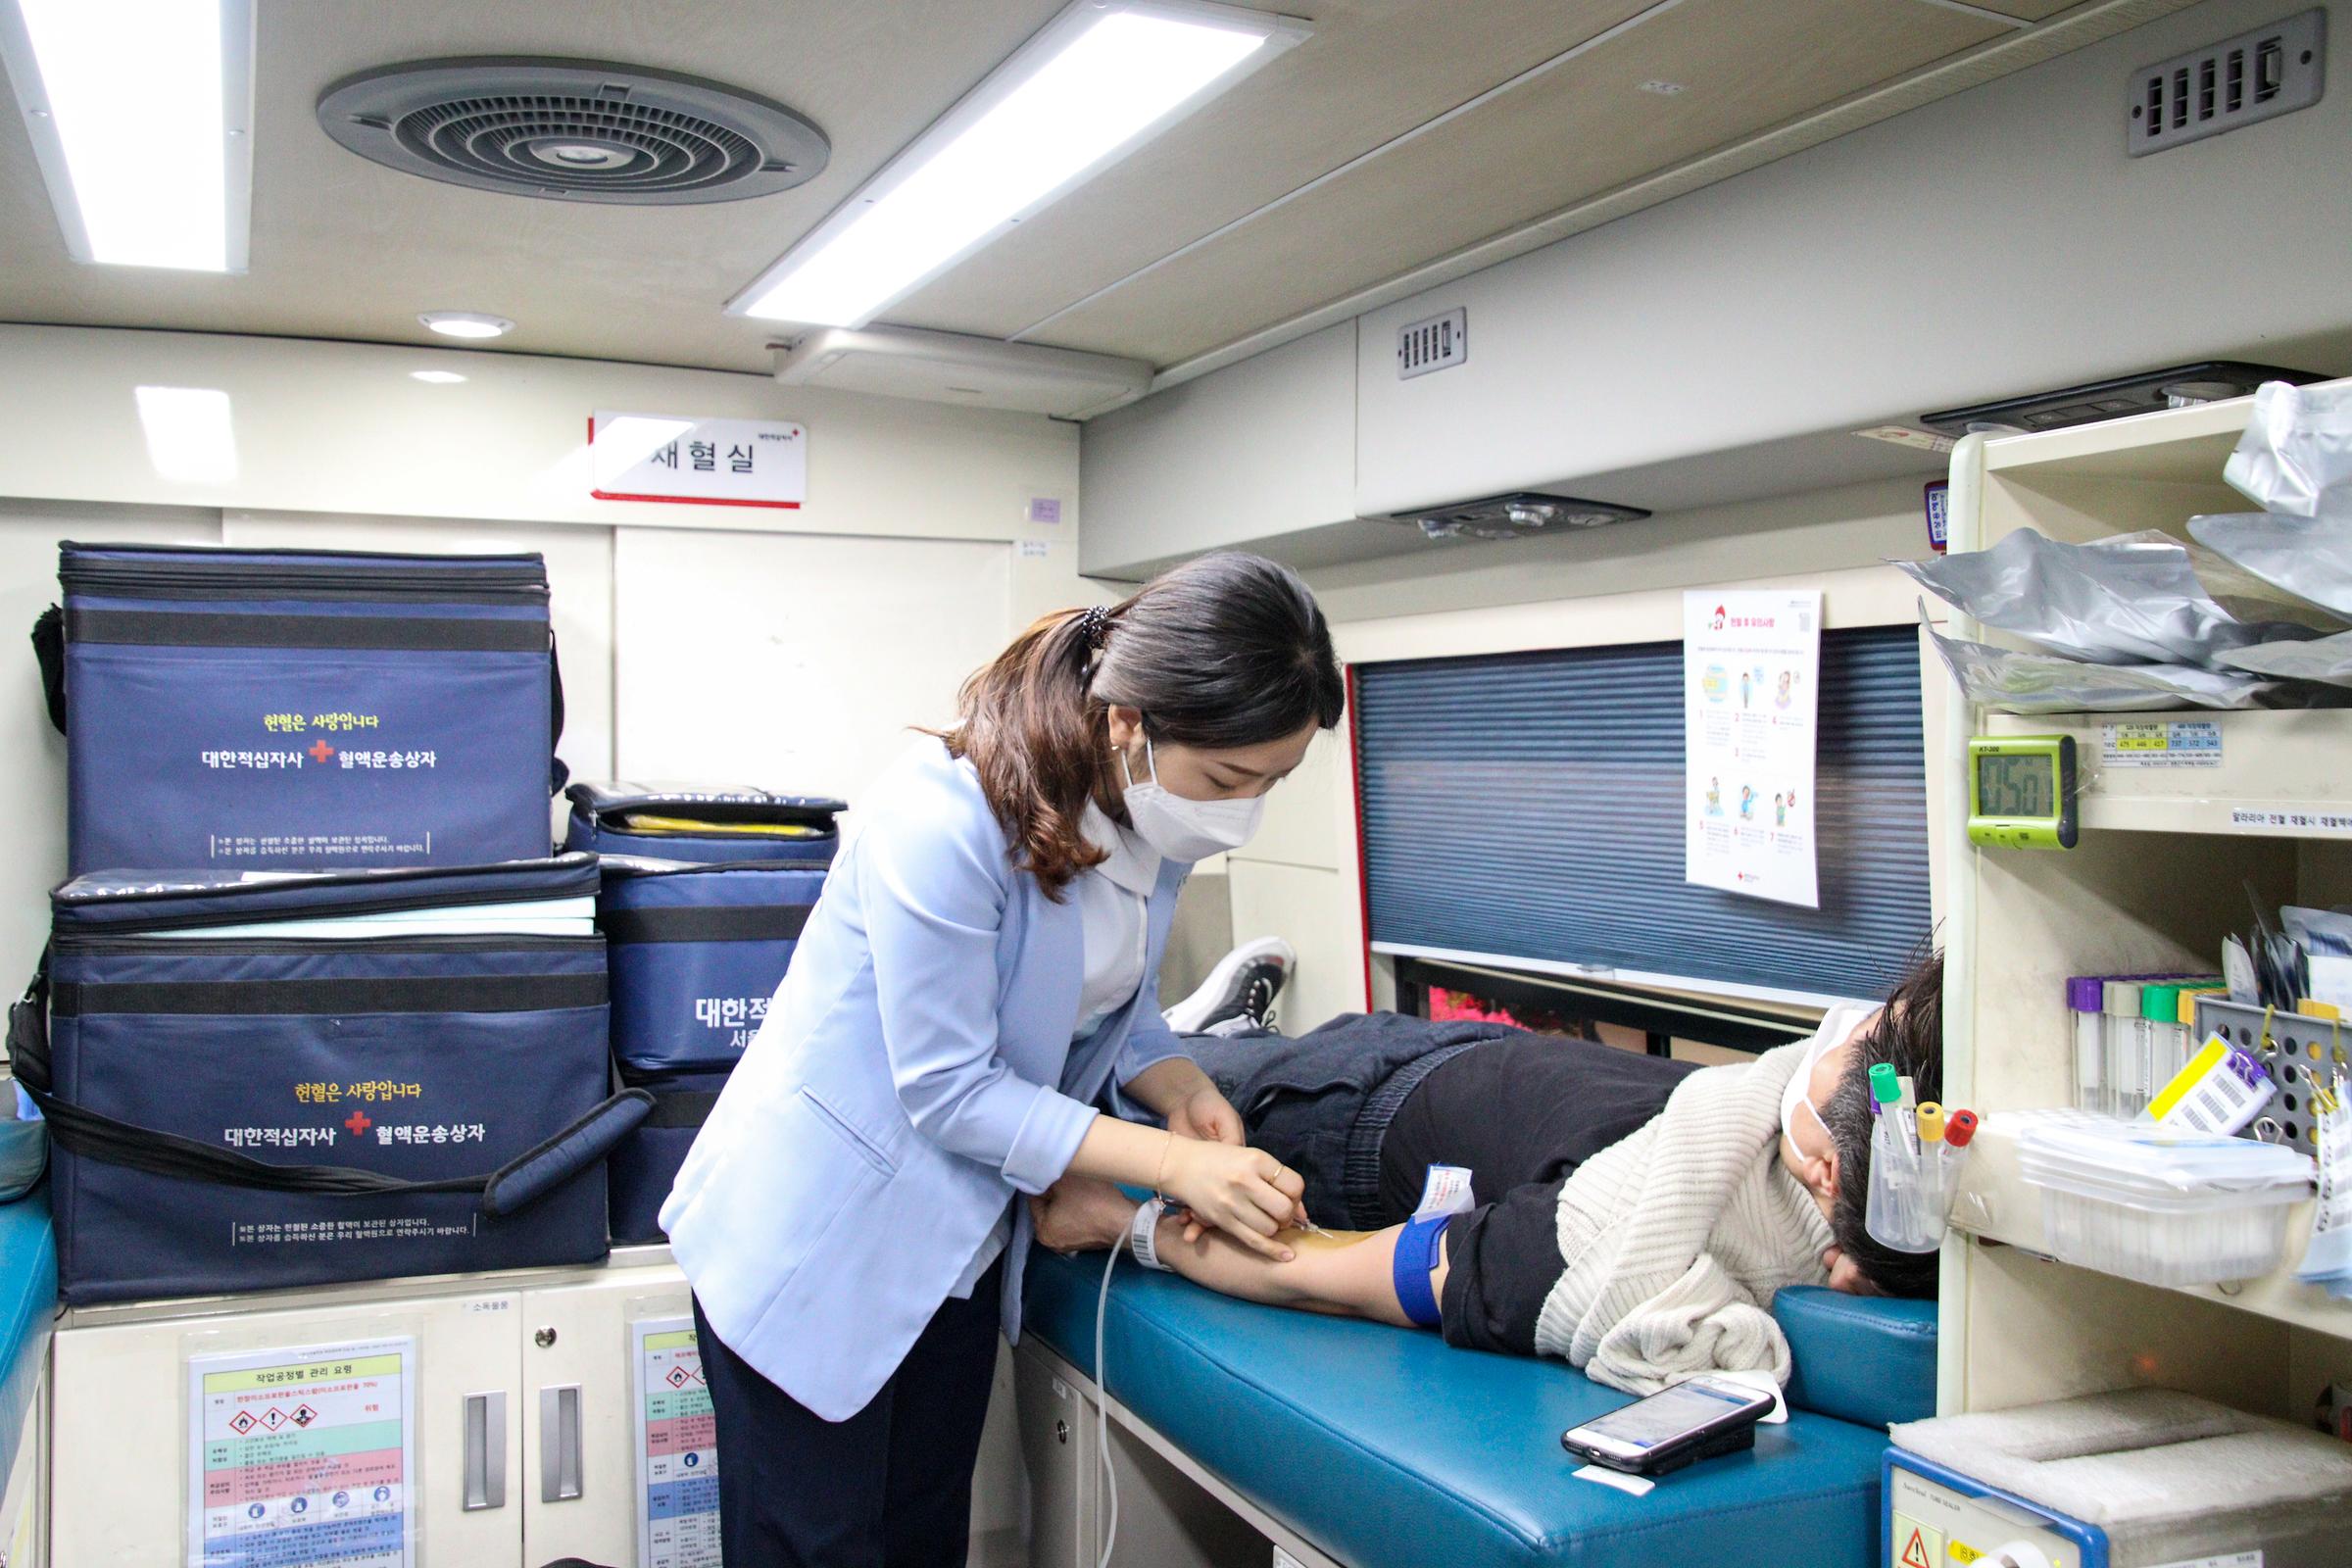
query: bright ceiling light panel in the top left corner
0 0 254 272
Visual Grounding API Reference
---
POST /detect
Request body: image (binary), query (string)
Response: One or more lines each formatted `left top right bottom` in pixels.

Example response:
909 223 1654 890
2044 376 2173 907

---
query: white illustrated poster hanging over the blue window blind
1682 588 1821 909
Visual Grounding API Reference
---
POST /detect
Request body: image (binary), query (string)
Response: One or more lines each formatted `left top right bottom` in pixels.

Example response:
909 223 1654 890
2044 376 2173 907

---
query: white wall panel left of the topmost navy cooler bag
0 499 221 992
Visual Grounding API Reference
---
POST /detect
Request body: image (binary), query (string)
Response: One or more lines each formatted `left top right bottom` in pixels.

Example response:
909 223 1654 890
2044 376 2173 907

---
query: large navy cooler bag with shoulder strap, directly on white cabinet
10 856 652 1304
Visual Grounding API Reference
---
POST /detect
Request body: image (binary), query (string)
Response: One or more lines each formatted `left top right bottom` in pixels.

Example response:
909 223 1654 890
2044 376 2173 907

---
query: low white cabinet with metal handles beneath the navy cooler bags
49 1249 689 1568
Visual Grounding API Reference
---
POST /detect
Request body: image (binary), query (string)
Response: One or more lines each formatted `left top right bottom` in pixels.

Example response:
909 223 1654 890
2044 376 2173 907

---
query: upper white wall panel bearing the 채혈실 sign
0 326 1077 541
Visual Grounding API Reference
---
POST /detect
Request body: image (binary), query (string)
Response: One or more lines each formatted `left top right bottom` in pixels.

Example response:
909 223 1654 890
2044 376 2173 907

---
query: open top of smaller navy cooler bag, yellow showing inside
564 783 849 865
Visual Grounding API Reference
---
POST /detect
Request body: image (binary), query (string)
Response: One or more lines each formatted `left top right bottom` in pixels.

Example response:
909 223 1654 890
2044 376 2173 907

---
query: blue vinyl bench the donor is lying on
1025 1250 1936 1568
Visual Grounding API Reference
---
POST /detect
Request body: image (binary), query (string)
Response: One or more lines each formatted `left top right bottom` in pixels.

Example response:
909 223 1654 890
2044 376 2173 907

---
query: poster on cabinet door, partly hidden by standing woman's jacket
628 1316 719 1568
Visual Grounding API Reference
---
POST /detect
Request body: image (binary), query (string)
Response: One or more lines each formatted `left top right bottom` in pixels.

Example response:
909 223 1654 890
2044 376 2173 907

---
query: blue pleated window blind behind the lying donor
1354 625 1931 997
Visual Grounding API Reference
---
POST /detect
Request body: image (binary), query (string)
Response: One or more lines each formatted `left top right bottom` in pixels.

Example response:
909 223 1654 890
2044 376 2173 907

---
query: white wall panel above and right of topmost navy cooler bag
221 513 612 799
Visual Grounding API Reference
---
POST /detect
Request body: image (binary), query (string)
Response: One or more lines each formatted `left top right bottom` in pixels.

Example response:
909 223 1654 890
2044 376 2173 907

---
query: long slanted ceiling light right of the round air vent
727 0 1305 326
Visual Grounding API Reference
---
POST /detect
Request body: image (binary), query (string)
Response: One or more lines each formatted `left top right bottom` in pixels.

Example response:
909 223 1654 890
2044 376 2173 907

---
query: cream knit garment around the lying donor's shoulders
1536 1044 1833 1394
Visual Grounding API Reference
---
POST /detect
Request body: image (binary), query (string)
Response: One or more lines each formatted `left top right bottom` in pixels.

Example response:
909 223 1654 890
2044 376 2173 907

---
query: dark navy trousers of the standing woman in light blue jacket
694 1260 1004 1568
